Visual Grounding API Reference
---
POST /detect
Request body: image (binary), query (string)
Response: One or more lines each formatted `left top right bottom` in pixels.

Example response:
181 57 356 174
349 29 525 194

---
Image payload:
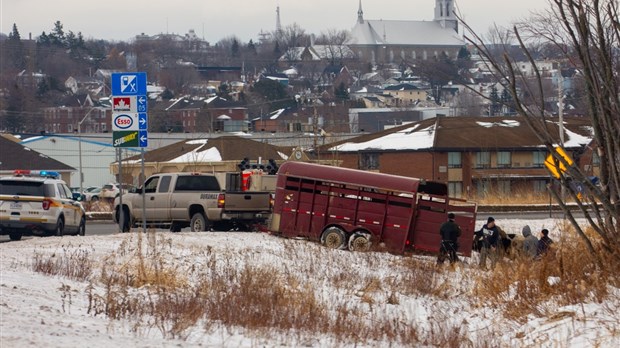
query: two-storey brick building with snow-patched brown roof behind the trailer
319 117 593 197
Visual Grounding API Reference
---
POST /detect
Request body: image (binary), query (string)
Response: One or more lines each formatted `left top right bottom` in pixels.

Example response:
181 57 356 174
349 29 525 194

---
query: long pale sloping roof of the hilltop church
349 20 465 46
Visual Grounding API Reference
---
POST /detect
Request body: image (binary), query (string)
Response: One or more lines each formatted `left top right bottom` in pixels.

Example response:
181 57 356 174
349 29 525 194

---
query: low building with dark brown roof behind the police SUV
0 134 76 183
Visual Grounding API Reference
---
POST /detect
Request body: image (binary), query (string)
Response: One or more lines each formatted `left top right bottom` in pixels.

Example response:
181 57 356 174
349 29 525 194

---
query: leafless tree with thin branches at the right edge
465 0 620 261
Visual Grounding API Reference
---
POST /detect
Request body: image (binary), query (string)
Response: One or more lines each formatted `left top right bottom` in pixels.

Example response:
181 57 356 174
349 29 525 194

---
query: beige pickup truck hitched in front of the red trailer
113 173 273 232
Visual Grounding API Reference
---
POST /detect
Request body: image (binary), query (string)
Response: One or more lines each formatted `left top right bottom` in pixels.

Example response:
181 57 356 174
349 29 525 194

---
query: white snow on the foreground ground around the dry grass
0 219 620 348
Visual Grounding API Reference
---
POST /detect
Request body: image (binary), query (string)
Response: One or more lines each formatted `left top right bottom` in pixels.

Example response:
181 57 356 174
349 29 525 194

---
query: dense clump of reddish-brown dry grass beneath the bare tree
474 227 620 321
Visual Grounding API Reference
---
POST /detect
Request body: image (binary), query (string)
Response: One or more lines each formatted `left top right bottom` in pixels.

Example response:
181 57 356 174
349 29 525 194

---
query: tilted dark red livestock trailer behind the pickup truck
271 162 476 256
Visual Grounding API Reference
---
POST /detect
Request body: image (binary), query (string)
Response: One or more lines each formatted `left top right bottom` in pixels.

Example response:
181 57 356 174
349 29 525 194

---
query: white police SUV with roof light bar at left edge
0 170 86 240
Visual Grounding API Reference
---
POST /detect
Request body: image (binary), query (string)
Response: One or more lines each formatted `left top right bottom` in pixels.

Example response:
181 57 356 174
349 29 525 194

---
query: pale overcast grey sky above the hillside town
0 0 549 44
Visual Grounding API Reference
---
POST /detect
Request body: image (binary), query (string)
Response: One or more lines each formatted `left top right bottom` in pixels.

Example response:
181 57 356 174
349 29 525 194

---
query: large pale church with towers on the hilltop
348 0 465 64
